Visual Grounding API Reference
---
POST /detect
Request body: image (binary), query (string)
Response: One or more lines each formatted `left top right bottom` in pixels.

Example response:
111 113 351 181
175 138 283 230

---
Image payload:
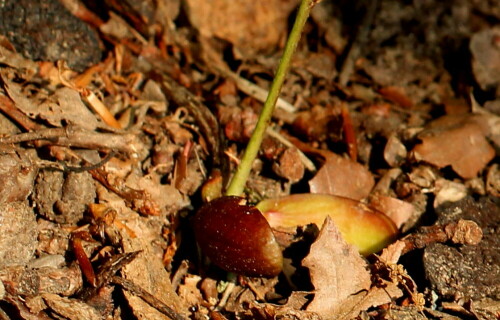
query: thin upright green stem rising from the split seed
226 0 317 196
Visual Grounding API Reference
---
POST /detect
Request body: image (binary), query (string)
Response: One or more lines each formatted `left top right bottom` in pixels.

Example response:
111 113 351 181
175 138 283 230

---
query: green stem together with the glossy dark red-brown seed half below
193 0 317 276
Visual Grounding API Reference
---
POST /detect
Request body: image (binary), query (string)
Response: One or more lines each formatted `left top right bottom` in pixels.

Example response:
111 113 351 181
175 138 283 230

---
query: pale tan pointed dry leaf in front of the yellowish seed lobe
303 217 371 319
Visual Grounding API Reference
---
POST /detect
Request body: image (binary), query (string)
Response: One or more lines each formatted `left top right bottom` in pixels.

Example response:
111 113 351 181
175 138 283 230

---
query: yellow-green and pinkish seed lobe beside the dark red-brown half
257 194 398 254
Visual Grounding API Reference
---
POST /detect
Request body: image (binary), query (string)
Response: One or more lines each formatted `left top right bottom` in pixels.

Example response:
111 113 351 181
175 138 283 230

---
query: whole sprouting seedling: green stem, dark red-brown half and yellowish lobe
193 0 397 276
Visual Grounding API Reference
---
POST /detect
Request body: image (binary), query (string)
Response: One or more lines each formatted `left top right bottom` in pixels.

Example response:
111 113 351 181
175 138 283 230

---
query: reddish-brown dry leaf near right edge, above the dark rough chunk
413 116 495 179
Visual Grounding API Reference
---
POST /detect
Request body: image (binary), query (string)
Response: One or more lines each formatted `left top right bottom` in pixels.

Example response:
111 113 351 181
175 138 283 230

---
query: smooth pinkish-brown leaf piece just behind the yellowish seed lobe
309 152 375 200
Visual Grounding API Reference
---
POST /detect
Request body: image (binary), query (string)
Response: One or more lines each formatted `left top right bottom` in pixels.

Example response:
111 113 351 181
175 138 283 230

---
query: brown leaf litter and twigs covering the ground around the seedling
0 0 500 319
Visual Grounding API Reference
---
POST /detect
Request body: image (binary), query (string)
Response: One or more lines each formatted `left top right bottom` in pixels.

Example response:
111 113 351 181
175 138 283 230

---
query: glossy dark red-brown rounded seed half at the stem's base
193 196 283 277
